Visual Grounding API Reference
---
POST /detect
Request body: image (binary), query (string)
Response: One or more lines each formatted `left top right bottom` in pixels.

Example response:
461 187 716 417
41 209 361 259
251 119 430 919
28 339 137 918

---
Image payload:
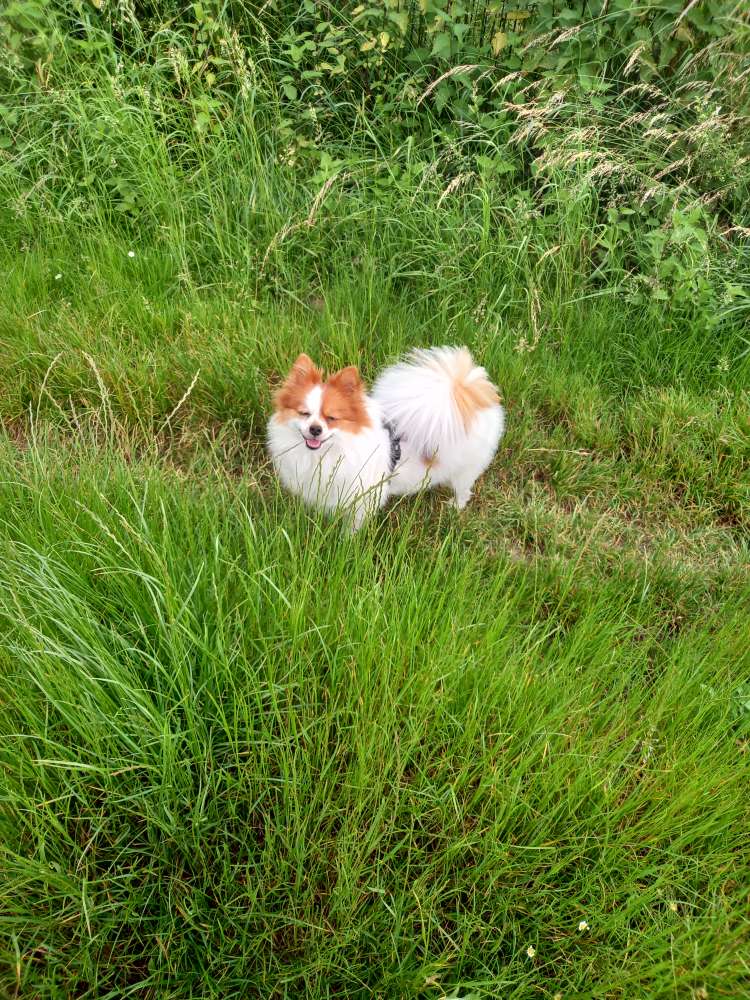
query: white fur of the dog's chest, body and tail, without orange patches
268 347 505 529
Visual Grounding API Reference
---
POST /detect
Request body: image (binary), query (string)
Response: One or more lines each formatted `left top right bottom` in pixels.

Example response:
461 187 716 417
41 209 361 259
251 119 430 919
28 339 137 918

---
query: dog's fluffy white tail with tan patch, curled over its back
372 347 500 457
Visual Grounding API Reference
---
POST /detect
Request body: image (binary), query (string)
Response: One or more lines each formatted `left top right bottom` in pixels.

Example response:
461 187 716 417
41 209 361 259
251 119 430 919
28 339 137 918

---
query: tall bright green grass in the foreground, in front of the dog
0 446 750 997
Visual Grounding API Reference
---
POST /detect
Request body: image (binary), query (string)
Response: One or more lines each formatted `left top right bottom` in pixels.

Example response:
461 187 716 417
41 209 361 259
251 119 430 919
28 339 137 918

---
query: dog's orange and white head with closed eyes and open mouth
274 354 370 451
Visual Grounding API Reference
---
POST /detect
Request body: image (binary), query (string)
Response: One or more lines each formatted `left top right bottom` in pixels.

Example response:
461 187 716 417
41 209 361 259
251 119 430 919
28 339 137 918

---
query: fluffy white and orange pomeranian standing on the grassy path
268 347 505 530
